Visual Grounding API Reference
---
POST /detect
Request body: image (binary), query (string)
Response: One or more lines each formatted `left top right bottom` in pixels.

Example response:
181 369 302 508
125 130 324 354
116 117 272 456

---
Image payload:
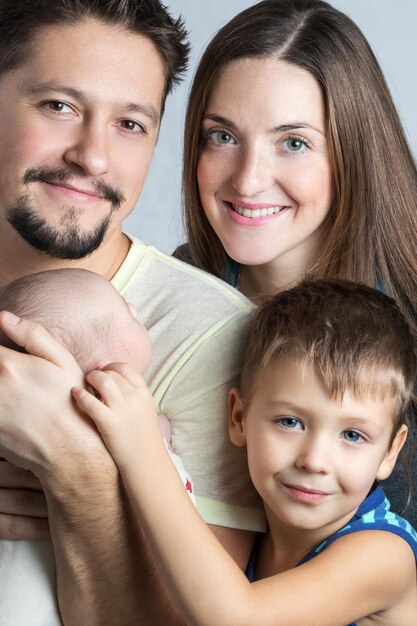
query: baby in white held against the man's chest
0 269 194 626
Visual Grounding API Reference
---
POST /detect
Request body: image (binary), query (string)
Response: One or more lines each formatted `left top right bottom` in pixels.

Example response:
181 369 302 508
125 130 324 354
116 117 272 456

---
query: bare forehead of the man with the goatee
12 19 165 111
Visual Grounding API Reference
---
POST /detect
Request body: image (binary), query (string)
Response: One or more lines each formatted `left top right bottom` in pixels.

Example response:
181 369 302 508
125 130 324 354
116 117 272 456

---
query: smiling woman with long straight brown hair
175 0 417 524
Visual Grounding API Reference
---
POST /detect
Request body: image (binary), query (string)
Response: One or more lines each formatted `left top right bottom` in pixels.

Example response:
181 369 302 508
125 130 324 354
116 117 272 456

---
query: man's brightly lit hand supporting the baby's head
0 312 94 476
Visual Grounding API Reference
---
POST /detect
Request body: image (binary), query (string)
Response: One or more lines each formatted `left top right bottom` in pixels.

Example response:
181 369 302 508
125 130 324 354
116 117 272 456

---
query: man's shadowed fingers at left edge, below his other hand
0 460 49 539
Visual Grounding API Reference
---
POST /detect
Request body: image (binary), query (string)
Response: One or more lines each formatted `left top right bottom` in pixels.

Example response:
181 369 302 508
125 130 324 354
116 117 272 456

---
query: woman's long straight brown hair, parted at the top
183 0 417 335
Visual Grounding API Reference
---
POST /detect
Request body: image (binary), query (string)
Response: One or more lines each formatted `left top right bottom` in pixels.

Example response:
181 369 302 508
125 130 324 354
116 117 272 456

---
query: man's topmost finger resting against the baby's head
0 311 76 368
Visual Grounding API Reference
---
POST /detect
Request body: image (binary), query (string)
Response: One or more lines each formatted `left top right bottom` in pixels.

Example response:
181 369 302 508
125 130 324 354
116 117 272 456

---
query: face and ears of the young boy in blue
230 359 406 541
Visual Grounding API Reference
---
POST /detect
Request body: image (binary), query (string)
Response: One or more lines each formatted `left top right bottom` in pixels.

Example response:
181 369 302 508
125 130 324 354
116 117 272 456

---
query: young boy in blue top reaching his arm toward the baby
73 280 417 626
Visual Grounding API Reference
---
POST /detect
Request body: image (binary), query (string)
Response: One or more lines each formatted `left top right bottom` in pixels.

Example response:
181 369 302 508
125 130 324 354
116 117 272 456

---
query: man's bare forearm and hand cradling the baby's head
0 314 252 626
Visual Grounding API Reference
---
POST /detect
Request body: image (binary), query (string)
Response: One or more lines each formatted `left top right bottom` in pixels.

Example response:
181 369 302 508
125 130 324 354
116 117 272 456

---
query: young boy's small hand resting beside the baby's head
72 363 161 468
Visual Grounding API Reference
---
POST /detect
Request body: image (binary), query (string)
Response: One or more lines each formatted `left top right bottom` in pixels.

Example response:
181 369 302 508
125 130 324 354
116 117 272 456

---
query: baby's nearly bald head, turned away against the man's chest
0 268 151 373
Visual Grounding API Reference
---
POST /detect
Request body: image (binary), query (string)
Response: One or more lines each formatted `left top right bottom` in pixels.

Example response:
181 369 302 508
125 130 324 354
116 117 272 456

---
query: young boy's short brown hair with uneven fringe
241 280 417 435
